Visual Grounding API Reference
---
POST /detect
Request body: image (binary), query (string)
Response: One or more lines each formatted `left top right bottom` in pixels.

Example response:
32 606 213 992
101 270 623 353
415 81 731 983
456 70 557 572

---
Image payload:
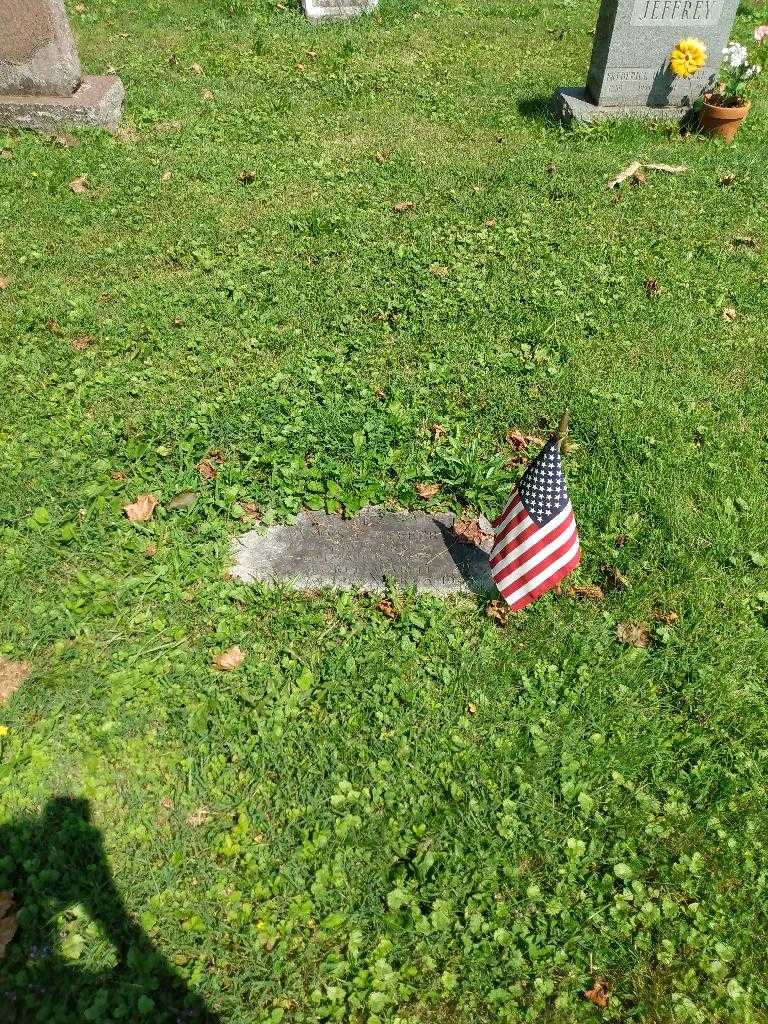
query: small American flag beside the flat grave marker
490 437 581 611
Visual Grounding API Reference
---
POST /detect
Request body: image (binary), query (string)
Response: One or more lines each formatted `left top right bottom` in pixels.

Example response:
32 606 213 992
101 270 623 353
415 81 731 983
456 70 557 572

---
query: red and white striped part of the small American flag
490 490 581 611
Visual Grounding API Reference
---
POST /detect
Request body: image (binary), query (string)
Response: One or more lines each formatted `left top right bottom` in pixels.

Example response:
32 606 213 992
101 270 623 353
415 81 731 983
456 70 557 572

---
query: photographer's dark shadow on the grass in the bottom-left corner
0 797 217 1024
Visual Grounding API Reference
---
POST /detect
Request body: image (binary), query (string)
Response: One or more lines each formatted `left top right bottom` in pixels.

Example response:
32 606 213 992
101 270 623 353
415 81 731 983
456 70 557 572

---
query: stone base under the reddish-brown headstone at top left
0 75 125 133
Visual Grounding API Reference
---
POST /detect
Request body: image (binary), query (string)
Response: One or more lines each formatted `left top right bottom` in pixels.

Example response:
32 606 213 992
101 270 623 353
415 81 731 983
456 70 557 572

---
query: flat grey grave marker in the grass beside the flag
231 508 496 595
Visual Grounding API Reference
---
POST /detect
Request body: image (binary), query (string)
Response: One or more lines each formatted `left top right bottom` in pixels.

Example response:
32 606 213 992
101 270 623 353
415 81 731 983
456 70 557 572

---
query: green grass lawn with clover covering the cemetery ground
0 0 768 1024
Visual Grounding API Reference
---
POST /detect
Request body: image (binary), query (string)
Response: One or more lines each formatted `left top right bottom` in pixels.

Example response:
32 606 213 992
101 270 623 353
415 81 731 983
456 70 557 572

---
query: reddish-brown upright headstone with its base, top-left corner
0 0 125 131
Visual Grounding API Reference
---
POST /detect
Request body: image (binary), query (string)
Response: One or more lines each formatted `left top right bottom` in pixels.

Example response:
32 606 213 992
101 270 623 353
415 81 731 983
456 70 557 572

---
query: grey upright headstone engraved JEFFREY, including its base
555 0 739 122
